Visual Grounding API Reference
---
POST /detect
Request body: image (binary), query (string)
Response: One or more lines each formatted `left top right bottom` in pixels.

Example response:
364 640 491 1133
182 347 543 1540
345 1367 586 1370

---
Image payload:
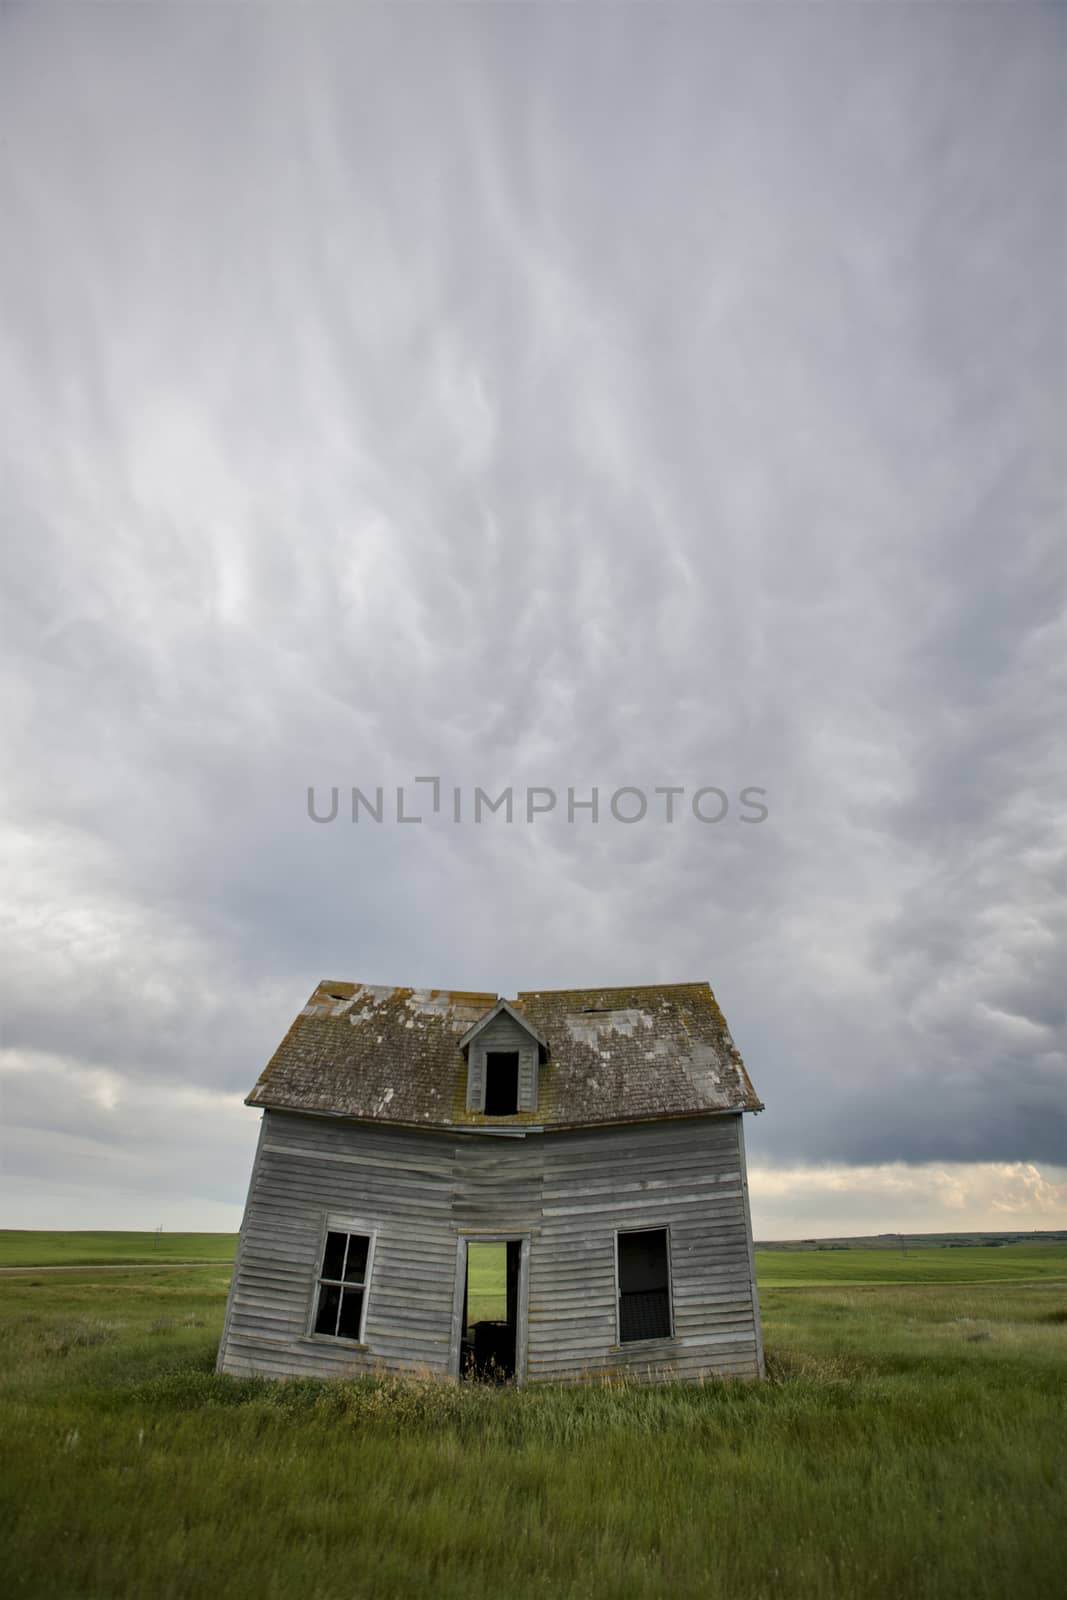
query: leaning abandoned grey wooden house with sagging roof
218 982 763 1382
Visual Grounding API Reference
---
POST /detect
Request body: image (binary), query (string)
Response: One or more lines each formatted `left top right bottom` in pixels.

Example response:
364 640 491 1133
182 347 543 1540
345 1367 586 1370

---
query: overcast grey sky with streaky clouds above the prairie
0 3 1067 1235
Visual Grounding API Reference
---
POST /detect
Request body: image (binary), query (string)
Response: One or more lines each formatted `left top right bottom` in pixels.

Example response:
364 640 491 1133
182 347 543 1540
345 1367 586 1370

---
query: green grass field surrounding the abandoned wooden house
0 1235 1067 1600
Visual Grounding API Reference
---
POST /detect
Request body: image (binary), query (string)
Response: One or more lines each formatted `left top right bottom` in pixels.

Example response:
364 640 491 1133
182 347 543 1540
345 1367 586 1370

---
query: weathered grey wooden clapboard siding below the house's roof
219 1112 763 1382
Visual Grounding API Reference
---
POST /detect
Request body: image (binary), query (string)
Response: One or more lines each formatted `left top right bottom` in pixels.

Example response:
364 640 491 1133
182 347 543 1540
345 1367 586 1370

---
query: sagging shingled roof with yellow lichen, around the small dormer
246 981 763 1131
